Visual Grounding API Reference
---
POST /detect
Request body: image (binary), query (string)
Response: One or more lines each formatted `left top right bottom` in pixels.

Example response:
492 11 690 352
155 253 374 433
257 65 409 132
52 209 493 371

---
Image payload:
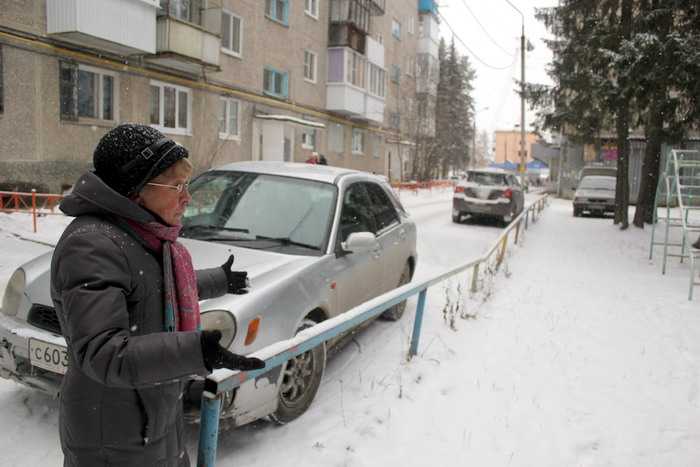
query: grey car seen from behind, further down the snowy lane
452 169 525 224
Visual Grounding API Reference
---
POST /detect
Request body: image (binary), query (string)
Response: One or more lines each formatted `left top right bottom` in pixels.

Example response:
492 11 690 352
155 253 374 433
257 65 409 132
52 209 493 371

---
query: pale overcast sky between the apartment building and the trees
438 0 557 141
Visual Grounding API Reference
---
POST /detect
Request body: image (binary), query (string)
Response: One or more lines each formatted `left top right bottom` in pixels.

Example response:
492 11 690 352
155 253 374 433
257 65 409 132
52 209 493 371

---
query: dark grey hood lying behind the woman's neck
59 172 156 223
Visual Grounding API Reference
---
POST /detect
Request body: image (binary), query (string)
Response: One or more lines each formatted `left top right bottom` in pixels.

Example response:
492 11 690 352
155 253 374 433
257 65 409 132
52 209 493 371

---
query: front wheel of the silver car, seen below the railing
270 319 326 425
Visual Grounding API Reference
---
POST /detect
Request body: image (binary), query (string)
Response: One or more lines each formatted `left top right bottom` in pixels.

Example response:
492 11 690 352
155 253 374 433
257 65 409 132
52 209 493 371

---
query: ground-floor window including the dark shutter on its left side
59 61 118 122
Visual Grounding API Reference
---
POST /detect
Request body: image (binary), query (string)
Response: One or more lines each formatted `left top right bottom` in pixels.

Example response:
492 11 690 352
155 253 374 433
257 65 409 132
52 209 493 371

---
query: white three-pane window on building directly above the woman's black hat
150 81 192 135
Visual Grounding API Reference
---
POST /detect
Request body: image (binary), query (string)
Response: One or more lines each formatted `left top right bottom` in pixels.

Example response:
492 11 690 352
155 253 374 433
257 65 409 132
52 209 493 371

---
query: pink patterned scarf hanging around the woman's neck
126 219 201 332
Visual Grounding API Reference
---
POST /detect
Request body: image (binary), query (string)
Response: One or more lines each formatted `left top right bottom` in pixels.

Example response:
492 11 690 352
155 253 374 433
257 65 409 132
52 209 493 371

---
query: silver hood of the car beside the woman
22 238 320 306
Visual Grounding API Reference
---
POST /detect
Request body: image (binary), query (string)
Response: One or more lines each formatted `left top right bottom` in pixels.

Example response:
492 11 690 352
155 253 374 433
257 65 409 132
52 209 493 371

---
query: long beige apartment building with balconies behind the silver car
0 0 434 191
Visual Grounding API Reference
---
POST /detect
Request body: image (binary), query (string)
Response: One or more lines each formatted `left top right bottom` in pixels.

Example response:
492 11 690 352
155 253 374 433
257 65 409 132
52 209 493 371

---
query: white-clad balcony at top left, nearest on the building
46 0 158 56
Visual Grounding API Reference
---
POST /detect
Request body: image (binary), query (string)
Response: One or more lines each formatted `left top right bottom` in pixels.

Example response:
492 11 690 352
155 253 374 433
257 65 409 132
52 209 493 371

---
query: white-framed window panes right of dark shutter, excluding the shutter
77 65 118 121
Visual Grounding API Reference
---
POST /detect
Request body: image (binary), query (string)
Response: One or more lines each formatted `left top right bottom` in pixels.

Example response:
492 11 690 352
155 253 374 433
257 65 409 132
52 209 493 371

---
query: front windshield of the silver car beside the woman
182 171 337 255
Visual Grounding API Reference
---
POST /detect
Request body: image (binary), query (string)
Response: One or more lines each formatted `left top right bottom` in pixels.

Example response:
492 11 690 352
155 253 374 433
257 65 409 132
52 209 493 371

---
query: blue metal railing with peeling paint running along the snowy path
197 195 548 467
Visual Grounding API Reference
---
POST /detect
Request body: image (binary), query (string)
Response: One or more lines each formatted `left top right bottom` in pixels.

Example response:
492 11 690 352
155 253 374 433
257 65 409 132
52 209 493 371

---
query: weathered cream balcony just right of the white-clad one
146 10 221 74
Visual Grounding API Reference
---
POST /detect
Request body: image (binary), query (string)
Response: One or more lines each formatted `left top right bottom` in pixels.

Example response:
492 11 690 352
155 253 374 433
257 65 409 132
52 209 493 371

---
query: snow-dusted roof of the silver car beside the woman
212 161 366 183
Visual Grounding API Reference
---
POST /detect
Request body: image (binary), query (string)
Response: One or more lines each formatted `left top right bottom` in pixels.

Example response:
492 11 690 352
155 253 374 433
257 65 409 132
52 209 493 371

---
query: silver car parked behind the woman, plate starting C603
0 162 417 425
